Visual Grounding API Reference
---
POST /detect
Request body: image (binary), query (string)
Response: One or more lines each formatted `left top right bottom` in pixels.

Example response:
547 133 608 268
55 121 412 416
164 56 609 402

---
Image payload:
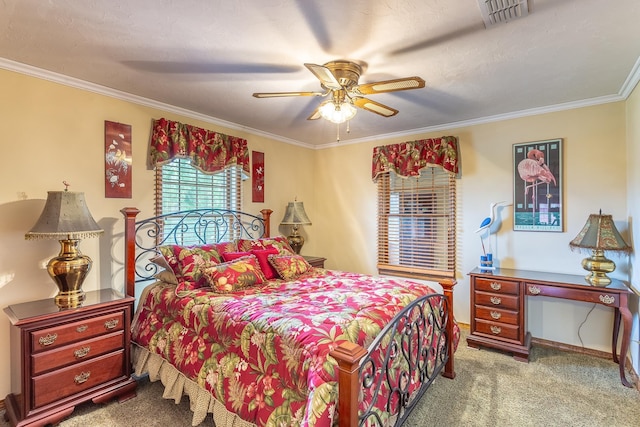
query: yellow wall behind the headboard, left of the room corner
0 70 321 400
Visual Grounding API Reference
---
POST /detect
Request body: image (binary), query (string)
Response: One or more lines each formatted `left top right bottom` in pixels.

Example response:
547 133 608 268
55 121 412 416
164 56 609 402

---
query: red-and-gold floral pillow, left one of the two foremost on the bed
203 255 266 293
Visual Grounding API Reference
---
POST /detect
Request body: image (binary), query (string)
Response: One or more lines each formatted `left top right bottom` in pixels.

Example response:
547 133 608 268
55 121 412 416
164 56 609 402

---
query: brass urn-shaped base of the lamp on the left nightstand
47 239 92 308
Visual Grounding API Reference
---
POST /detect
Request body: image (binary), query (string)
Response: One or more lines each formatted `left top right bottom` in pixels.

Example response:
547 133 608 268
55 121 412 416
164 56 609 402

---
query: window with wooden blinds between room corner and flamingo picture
378 167 456 279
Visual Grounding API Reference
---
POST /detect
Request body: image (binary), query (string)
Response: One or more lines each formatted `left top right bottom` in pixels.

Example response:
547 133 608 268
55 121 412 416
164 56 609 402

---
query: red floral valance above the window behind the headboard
149 119 250 176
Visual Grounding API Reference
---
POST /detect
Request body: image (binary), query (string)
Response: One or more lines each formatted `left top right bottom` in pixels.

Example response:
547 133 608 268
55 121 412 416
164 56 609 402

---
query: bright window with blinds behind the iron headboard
156 158 242 245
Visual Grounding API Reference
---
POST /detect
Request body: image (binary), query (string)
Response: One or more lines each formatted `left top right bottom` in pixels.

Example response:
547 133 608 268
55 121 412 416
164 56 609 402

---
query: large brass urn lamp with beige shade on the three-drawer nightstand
24 189 104 308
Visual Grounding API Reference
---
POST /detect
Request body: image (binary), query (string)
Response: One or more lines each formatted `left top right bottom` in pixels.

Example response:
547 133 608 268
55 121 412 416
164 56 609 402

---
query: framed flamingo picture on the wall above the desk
513 139 564 231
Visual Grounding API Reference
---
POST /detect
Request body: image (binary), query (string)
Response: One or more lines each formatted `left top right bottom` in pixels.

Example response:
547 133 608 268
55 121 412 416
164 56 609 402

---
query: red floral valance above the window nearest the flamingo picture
371 136 460 181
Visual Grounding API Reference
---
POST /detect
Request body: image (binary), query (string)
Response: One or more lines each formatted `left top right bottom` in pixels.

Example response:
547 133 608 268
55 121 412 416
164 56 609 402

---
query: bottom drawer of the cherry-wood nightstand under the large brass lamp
33 350 124 408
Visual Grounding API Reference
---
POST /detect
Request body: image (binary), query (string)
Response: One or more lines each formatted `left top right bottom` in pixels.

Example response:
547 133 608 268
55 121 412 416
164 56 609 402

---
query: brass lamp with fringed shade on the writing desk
569 211 631 286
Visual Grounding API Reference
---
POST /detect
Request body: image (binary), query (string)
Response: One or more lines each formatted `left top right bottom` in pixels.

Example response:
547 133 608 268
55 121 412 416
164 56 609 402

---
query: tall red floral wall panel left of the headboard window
104 120 131 199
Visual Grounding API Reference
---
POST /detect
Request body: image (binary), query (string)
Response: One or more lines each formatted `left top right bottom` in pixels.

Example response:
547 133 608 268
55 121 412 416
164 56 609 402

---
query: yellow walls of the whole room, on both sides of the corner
0 66 640 398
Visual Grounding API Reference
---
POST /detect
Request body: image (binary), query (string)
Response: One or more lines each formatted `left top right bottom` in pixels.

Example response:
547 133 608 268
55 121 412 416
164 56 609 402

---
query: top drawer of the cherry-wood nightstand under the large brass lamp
31 311 124 353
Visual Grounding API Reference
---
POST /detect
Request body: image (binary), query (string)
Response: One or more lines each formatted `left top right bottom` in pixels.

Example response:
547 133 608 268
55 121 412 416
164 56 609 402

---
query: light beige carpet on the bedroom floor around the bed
0 330 640 427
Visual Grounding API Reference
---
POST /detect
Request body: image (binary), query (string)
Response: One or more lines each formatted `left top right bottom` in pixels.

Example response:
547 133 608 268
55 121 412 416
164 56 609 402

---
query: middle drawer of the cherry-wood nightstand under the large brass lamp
31 331 124 375
